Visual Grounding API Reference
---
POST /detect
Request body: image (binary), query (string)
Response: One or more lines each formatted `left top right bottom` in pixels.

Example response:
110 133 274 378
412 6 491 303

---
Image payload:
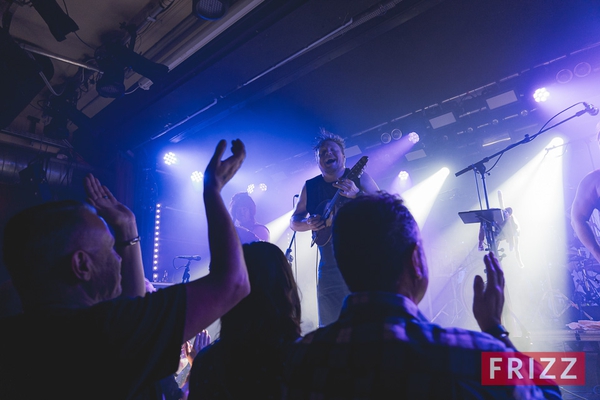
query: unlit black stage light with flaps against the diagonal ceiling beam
94 41 169 98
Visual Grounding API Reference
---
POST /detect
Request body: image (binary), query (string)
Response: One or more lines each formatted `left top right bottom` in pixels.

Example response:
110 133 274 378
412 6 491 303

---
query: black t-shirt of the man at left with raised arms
0 285 186 399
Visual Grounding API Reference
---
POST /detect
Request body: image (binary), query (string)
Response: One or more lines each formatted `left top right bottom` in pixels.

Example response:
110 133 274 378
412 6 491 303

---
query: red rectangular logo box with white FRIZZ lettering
481 352 585 386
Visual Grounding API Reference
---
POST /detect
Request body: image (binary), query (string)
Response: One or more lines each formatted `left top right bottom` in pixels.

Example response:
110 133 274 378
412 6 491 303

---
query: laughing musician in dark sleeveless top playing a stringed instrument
290 129 379 326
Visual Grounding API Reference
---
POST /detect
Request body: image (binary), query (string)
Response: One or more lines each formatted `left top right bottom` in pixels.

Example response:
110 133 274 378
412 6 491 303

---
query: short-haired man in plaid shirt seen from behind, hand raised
285 193 561 400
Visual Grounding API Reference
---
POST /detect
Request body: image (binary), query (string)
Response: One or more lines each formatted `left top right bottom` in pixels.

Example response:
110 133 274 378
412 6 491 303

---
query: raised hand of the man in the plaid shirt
473 252 504 331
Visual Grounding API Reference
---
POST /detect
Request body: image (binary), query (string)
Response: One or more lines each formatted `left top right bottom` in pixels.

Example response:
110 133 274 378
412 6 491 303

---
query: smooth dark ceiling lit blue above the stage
74 0 600 175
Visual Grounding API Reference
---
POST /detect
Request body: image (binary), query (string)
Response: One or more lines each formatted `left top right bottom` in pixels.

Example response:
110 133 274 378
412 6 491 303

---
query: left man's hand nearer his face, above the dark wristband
83 174 135 227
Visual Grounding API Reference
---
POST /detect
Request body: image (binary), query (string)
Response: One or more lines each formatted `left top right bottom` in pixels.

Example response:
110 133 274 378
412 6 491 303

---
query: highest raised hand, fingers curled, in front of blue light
204 139 246 192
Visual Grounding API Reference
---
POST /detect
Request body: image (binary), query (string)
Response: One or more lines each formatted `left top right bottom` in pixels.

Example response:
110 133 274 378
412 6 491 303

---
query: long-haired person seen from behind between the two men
189 242 301 400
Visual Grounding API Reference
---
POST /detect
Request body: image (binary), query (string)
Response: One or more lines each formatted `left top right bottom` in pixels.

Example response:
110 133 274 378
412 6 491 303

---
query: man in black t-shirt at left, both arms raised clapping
0 140 250 400
